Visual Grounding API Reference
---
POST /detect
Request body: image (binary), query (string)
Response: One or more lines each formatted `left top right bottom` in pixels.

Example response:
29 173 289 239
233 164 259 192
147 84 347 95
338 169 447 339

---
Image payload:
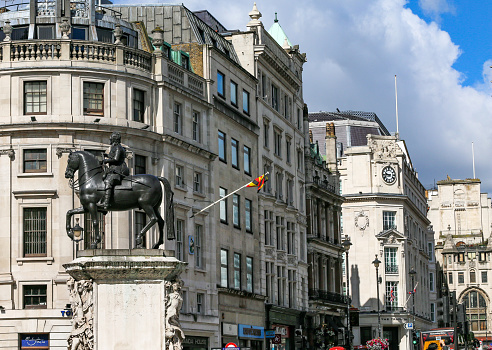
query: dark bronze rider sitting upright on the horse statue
102 131 130 210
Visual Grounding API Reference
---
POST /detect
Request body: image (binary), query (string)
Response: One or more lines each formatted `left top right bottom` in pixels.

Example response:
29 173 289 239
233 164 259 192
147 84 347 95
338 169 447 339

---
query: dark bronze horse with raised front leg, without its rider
65 151 175 249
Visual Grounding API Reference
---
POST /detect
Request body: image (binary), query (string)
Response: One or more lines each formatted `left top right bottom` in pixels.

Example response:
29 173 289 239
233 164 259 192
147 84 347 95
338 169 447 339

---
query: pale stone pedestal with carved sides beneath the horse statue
63 249 185 350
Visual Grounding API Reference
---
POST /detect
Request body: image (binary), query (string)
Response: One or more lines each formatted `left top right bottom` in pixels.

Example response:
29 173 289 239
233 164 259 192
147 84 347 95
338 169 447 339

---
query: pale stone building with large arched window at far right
427 177 492 343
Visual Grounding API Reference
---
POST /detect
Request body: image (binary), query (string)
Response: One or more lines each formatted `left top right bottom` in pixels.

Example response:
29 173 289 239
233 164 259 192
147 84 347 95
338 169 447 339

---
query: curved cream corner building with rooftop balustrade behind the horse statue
0 1 219 349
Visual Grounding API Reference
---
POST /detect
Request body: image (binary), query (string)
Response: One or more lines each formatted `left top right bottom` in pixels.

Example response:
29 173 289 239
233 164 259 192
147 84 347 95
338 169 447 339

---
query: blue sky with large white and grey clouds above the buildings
113 0 492 194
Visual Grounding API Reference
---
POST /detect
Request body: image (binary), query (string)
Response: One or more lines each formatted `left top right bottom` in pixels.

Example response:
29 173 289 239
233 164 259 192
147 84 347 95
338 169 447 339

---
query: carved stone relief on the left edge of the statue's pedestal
67 277 94 350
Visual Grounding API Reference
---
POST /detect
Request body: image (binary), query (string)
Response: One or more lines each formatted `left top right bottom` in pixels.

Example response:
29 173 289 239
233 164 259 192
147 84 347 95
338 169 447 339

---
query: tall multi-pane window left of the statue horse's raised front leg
23 208 47 257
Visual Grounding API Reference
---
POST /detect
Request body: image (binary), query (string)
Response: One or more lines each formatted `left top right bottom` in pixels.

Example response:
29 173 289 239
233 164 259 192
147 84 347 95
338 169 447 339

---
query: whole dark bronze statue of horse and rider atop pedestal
65 132 175 249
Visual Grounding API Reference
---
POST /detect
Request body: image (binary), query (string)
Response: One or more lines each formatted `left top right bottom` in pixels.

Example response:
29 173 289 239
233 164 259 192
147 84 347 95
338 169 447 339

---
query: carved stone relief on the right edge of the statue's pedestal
165 279 185 350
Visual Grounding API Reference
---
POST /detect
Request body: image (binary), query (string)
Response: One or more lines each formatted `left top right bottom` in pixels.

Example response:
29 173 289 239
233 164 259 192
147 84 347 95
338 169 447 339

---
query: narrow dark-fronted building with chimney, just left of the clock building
305 123 350 348
